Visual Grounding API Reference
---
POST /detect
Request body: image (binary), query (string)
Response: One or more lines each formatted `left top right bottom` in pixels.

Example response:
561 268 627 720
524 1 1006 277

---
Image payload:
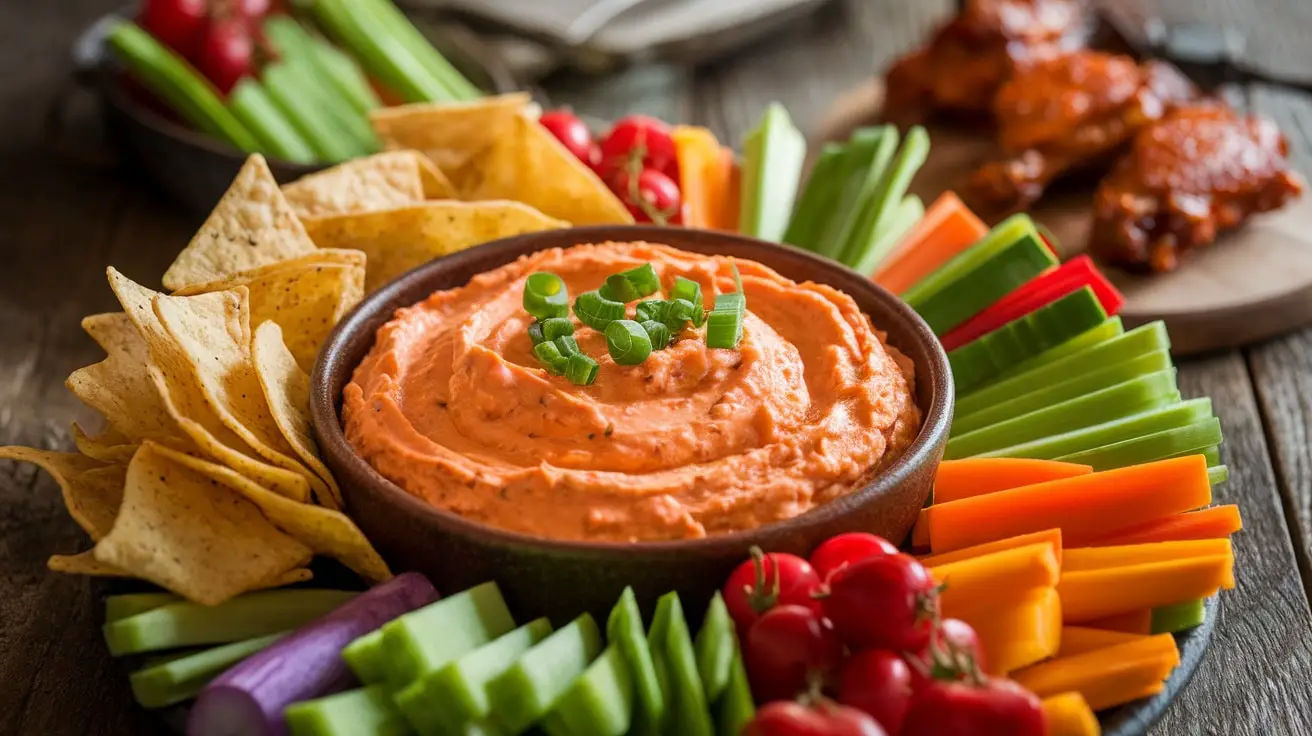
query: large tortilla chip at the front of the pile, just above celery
94 442 312 606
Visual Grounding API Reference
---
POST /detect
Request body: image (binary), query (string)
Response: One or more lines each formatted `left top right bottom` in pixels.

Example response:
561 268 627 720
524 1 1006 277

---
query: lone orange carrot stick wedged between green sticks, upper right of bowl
874 192 988 294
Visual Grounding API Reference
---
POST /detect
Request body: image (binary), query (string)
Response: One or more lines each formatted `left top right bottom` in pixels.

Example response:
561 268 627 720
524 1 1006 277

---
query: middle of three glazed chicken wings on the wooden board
966 51 1195 214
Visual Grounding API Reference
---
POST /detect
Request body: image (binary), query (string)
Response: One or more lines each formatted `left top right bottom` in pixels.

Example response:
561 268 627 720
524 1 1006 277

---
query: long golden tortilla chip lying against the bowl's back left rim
308 199 567 293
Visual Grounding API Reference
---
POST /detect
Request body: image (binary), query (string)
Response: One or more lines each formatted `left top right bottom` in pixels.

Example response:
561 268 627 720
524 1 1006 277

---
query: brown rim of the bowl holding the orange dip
310 224 954 555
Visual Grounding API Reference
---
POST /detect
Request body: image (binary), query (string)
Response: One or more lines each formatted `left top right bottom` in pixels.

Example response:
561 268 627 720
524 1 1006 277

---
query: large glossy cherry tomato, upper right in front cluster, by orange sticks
821 554 938 652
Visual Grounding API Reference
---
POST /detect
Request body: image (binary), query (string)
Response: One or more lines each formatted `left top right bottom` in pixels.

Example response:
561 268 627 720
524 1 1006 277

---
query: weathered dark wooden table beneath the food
0 0 1312 736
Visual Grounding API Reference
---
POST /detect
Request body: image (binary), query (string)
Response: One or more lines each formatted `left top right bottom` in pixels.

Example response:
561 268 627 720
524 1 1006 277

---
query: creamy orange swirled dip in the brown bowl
342 243 921 541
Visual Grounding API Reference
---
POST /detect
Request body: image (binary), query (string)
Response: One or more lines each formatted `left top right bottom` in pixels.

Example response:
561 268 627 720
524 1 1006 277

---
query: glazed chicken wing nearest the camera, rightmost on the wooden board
1089 104 1304 272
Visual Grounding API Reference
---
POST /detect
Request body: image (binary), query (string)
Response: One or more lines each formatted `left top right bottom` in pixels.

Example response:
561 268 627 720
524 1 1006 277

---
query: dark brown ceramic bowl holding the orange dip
311 226 953 623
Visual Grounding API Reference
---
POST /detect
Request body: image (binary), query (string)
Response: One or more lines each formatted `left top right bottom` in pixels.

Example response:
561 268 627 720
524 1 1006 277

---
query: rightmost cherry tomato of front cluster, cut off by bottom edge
901 677 1047 736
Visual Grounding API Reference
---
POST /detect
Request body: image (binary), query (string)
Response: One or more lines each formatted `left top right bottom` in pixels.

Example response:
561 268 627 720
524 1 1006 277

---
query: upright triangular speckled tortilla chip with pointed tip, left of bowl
164 153 315 289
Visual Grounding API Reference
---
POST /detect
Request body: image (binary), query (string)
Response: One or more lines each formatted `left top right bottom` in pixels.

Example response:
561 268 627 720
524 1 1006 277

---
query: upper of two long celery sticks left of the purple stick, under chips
104 589 356 657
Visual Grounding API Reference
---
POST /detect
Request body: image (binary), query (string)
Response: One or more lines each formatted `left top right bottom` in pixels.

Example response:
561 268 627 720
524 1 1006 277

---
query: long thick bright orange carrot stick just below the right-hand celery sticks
929 455 1212 554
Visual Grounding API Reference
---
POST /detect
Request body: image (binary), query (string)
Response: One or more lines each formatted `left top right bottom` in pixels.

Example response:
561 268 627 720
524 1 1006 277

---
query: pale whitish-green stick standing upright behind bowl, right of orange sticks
740 102 807 243
